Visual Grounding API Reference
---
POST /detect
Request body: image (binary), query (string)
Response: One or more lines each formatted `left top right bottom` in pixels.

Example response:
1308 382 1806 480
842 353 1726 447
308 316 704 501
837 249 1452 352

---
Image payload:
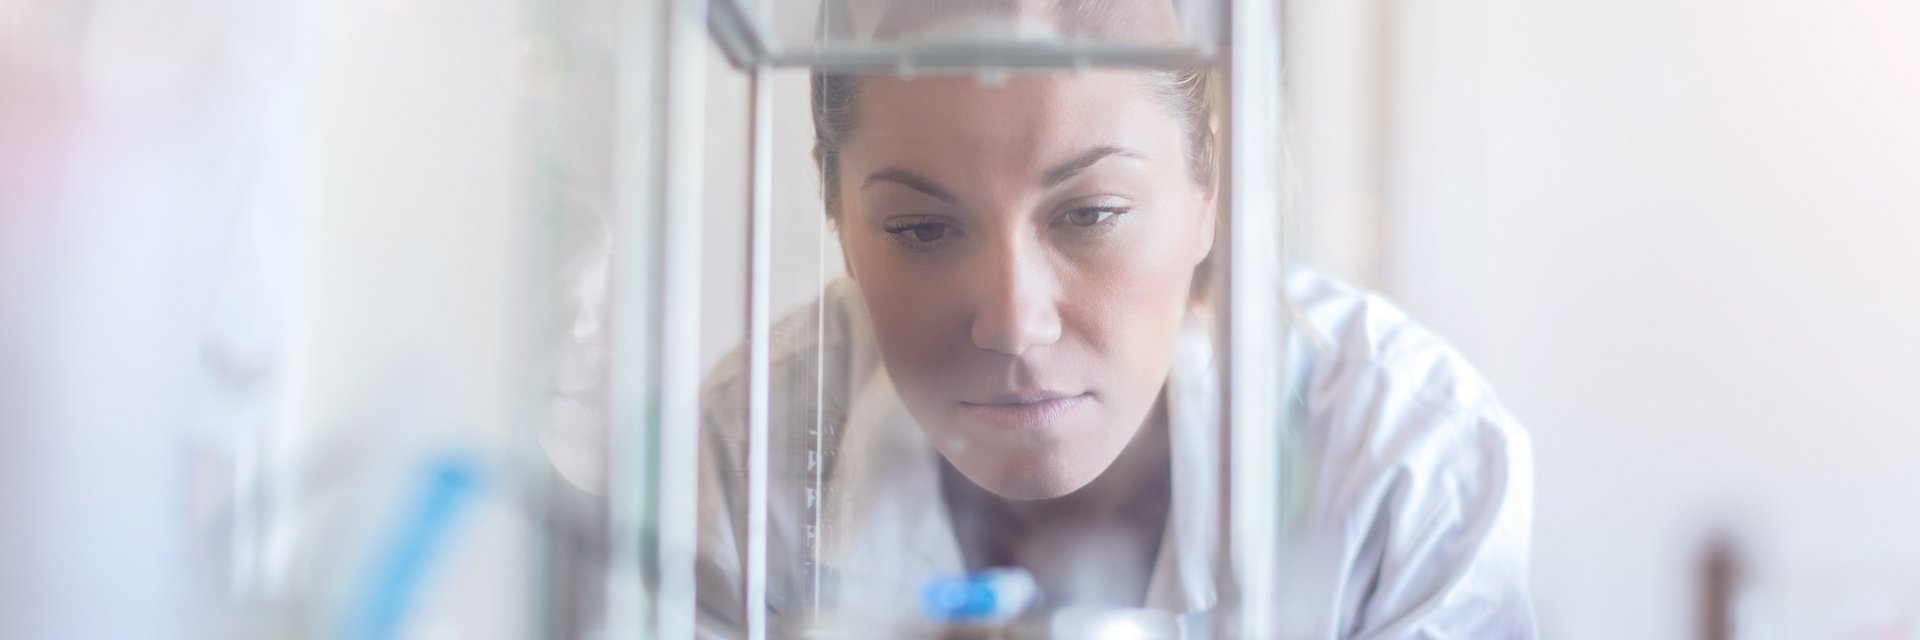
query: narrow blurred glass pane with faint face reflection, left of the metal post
513 0 618 638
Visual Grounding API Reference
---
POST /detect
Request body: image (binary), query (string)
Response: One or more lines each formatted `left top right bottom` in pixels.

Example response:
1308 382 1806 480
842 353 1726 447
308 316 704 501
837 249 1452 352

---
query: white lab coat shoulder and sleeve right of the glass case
1288 271 1534 638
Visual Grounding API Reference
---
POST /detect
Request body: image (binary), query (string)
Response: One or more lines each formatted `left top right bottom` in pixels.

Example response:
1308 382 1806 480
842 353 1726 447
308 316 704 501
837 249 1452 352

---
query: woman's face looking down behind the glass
835 71 1213 500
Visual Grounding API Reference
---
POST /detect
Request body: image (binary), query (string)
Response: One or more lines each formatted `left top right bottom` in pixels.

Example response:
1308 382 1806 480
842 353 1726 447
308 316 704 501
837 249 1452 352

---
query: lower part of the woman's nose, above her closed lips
973 242 1060 356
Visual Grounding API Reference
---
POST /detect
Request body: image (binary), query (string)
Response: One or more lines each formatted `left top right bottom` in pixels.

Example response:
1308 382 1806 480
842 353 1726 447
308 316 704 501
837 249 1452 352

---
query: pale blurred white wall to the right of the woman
1384 0 1920 638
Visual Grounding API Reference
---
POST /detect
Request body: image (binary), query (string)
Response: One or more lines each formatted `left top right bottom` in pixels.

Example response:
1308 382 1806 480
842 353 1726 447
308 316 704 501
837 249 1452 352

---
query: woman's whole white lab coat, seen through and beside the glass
699 269 1534 638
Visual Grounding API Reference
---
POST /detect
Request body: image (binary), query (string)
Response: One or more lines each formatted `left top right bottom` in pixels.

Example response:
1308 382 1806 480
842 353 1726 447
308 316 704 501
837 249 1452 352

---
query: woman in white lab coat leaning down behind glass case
699 2 1534 638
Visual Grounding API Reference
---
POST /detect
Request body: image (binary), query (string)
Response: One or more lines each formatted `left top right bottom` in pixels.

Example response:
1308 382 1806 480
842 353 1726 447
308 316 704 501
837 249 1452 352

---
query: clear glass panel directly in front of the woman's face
670 2 1271 622
